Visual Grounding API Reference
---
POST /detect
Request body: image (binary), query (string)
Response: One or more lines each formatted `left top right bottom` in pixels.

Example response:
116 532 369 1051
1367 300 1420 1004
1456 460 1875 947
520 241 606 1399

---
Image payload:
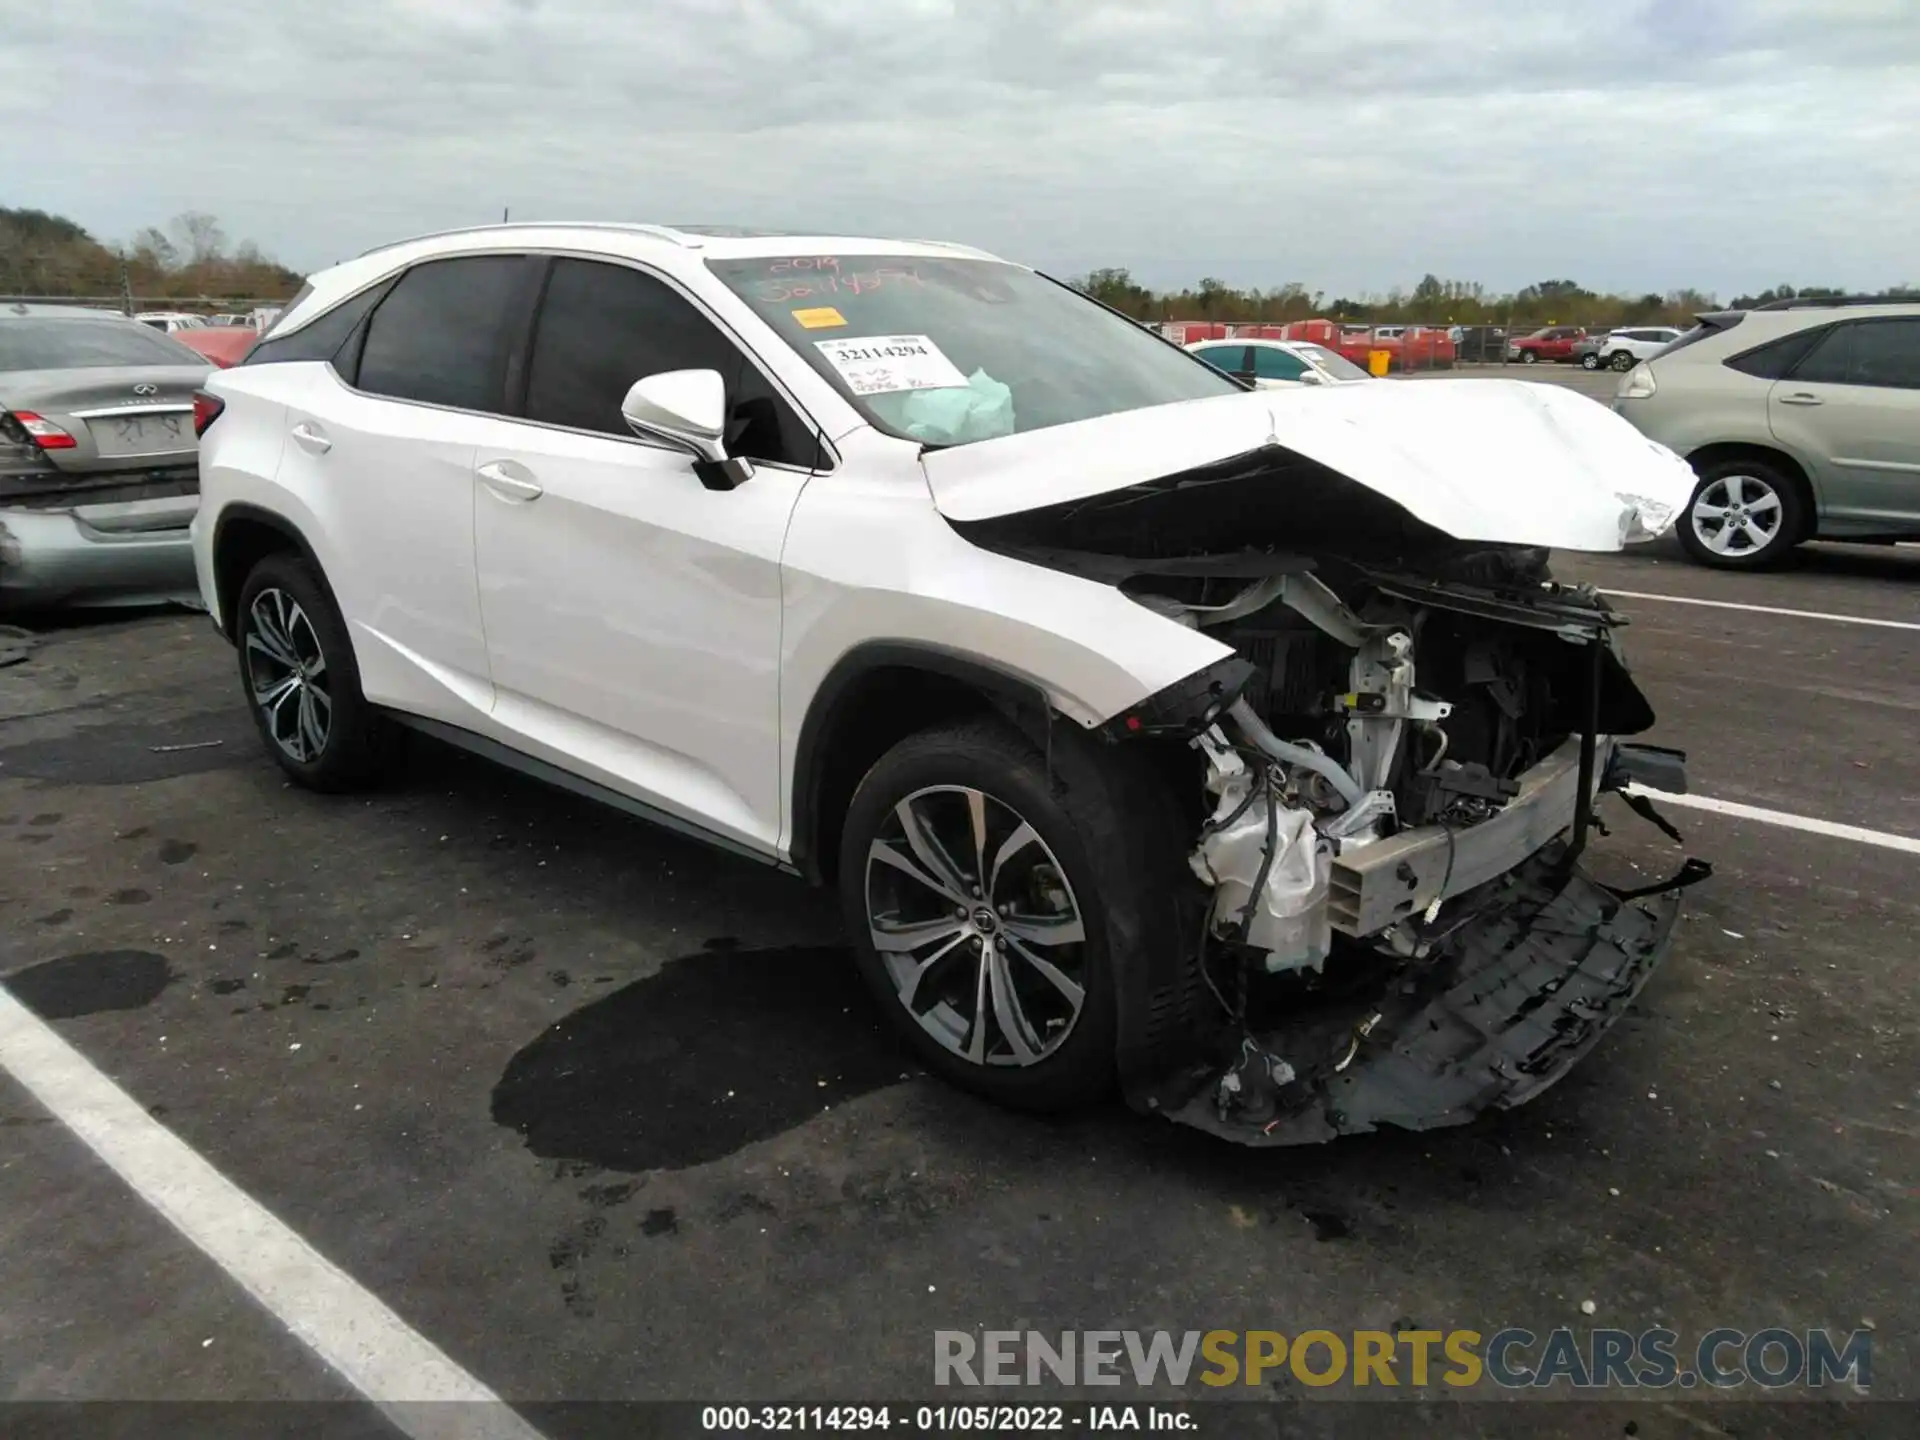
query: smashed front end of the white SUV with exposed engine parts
948 384 1709 1144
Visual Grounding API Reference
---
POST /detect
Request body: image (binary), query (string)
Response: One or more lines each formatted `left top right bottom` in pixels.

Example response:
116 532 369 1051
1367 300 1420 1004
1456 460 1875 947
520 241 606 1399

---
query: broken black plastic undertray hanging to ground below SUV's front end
1129 841 1697 1146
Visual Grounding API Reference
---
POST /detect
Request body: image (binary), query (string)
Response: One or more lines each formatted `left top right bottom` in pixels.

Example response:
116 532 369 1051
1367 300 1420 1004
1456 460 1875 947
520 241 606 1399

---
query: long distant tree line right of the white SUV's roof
1068 267 1920 328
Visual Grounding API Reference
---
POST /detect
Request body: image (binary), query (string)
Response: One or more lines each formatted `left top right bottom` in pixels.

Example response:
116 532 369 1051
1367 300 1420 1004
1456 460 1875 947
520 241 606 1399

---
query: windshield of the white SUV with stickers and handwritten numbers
707 255 1244 445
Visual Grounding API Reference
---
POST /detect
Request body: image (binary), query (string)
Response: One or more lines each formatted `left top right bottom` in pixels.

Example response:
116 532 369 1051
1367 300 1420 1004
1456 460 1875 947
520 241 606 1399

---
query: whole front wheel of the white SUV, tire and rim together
839 720 1175 1110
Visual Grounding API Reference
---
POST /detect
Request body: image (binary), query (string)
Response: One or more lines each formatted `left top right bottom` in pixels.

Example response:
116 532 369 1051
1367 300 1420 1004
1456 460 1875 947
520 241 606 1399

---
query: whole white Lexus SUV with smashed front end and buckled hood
194 225 1703 1144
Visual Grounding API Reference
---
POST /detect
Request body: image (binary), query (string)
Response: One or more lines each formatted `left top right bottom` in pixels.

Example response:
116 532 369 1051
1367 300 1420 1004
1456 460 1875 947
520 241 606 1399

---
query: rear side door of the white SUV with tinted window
264 255 532 728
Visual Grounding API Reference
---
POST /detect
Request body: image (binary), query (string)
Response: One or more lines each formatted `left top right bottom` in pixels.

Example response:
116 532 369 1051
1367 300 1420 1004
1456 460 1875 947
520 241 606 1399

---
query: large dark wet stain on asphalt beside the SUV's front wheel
480 947 908 1173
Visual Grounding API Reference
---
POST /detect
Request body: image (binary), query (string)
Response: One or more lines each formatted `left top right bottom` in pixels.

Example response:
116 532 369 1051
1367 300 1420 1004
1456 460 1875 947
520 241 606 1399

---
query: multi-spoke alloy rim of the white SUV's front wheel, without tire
866 785 1087 1066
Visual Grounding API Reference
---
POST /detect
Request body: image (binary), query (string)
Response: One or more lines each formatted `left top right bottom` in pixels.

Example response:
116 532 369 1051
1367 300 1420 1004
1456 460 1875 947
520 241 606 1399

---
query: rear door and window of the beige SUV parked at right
1766 317 1920 530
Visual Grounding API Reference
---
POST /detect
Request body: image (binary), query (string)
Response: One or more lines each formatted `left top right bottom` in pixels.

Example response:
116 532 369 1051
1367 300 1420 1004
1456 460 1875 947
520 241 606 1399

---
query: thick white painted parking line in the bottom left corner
0 987 541 1440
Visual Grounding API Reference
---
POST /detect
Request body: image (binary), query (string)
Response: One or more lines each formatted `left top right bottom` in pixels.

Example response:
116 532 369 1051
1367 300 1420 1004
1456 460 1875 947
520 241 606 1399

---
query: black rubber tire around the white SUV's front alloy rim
839 718 1177 1110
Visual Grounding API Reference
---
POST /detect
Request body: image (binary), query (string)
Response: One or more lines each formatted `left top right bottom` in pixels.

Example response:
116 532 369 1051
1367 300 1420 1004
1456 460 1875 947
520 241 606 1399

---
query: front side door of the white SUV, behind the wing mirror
472 257 822 852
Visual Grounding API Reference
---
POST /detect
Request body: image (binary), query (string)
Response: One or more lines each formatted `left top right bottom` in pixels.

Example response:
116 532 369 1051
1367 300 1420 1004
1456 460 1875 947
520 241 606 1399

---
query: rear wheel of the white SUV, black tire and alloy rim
234 553 394 791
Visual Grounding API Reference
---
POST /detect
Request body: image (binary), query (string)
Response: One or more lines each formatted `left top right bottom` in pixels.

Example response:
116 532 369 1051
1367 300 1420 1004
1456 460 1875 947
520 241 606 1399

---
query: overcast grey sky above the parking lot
0 0 1920 298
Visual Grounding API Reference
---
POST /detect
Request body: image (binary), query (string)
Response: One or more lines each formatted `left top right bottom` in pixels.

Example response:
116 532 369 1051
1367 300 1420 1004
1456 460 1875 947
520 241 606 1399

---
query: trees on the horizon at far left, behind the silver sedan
0 205 303 305
